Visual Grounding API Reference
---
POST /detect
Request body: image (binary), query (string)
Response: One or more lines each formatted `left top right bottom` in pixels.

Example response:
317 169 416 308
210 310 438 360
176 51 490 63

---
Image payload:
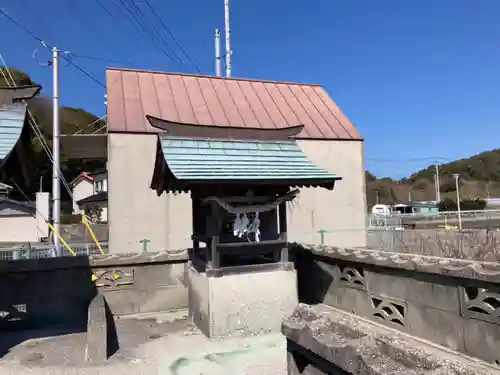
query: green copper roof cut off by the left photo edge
0 103 26 167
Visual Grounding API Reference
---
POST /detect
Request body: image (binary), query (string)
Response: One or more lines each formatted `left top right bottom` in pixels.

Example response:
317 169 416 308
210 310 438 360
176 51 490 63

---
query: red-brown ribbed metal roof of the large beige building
106 68 361 140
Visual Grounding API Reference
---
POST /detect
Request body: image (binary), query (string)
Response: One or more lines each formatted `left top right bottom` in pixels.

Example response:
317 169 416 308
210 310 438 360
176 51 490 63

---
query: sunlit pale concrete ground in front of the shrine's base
0 312 286 375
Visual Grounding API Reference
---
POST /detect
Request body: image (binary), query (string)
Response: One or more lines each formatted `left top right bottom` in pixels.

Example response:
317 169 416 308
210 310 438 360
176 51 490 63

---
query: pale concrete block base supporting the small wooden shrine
188 263 298 338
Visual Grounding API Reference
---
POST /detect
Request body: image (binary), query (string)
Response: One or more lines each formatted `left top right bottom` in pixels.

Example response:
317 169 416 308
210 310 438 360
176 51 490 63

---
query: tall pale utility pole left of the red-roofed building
52 47 62 256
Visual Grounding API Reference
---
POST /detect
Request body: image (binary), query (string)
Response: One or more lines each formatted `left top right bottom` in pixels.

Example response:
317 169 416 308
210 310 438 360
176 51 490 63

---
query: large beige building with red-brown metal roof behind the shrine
106 69 367 252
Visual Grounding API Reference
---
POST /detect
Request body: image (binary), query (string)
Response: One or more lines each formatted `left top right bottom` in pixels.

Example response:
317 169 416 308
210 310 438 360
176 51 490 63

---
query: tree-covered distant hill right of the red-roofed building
366 149 500 207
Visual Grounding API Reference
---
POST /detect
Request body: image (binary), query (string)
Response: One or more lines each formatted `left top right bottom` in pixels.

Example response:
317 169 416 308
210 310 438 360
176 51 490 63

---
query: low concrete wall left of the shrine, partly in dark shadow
0 250 188 330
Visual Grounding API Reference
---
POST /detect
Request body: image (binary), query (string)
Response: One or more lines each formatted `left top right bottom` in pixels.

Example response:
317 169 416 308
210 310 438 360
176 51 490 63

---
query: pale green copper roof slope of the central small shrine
159 135 340 182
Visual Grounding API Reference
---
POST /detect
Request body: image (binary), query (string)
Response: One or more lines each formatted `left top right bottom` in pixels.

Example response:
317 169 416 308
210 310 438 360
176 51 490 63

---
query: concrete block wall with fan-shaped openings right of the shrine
295 246 500 373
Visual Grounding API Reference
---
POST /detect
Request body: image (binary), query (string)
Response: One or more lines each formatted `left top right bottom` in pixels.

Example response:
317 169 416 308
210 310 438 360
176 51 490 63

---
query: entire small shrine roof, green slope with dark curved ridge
151 123 341 194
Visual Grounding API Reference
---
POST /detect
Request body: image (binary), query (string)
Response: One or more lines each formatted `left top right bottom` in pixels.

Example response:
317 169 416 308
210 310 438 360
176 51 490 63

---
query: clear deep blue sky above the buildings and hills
0 0 500 177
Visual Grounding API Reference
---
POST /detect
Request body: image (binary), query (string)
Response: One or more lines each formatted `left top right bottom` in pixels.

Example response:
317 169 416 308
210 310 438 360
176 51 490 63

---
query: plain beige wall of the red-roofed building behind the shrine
108 134 366 252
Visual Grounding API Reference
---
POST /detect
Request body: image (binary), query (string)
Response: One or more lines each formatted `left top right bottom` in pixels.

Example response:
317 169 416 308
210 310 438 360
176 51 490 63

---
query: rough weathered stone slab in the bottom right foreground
282 304 498 375
